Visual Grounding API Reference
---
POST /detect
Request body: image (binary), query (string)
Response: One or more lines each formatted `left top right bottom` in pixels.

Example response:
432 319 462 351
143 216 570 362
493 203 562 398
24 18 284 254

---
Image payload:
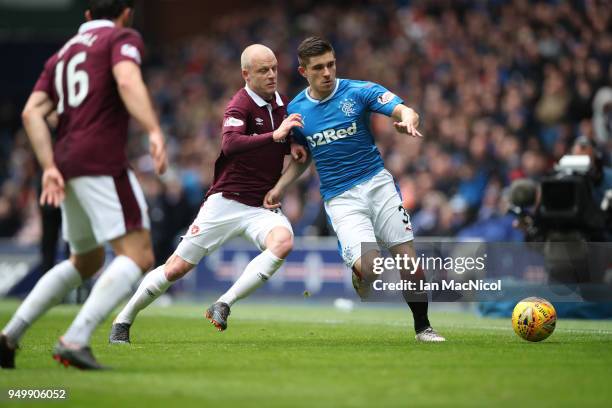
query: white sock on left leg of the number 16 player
2 260 82 344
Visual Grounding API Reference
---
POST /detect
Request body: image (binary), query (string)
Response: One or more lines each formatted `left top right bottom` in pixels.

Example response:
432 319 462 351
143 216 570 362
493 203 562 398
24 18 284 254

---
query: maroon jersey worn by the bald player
206 88 290 207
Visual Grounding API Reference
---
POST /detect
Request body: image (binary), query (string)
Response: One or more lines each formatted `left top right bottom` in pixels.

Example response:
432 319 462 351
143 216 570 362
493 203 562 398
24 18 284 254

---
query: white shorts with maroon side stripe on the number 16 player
61 170 151 254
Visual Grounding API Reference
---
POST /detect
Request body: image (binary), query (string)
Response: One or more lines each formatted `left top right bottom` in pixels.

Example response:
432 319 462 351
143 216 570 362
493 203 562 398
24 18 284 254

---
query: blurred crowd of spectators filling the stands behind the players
0 0 612 255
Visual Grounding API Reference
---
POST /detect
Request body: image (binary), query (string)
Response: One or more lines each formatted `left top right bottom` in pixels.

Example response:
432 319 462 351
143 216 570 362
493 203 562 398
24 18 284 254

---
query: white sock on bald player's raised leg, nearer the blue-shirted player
217 249 285 306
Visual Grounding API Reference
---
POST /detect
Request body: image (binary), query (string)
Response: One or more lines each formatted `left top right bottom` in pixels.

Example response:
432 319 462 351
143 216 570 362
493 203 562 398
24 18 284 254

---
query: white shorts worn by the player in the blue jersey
325 169 414 268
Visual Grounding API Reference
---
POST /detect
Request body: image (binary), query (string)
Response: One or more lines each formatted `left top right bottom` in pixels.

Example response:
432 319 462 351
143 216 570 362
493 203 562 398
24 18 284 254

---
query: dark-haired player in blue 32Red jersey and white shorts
264 37 445 342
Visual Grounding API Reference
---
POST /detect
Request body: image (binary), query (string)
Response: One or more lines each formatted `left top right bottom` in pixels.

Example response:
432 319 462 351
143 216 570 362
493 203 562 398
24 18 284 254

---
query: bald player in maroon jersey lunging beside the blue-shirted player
109 44 306 343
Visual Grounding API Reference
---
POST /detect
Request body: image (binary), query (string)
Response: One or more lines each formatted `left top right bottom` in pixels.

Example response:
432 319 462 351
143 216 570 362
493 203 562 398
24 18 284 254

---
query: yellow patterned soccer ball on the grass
512 297 557 341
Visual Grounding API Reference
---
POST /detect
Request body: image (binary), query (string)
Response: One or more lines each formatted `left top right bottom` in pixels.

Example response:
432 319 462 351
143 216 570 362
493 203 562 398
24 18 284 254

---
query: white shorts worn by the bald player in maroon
174 193 293 265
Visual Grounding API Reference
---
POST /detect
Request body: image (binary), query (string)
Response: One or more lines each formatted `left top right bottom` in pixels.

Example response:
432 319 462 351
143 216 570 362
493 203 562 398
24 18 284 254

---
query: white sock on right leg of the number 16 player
64 255 142 346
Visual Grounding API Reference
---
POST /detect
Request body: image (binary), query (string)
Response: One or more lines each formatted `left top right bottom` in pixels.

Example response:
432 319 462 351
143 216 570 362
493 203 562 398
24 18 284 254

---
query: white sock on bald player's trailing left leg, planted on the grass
114 265 174 324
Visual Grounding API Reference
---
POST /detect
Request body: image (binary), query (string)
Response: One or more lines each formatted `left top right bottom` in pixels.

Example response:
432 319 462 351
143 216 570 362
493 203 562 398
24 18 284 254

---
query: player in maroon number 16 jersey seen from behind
0 0 166 369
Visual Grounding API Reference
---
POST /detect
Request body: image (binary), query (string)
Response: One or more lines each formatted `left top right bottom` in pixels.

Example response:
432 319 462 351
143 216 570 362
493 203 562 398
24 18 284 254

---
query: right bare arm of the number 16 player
113 61 168 174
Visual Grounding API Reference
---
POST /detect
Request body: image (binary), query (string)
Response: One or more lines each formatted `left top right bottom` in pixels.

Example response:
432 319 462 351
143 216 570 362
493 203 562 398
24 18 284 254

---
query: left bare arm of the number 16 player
21 91 64 207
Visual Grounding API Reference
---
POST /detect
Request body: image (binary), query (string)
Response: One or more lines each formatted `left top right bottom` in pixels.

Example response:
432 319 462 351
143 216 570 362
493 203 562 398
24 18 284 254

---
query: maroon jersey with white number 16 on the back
34 20 144 179
